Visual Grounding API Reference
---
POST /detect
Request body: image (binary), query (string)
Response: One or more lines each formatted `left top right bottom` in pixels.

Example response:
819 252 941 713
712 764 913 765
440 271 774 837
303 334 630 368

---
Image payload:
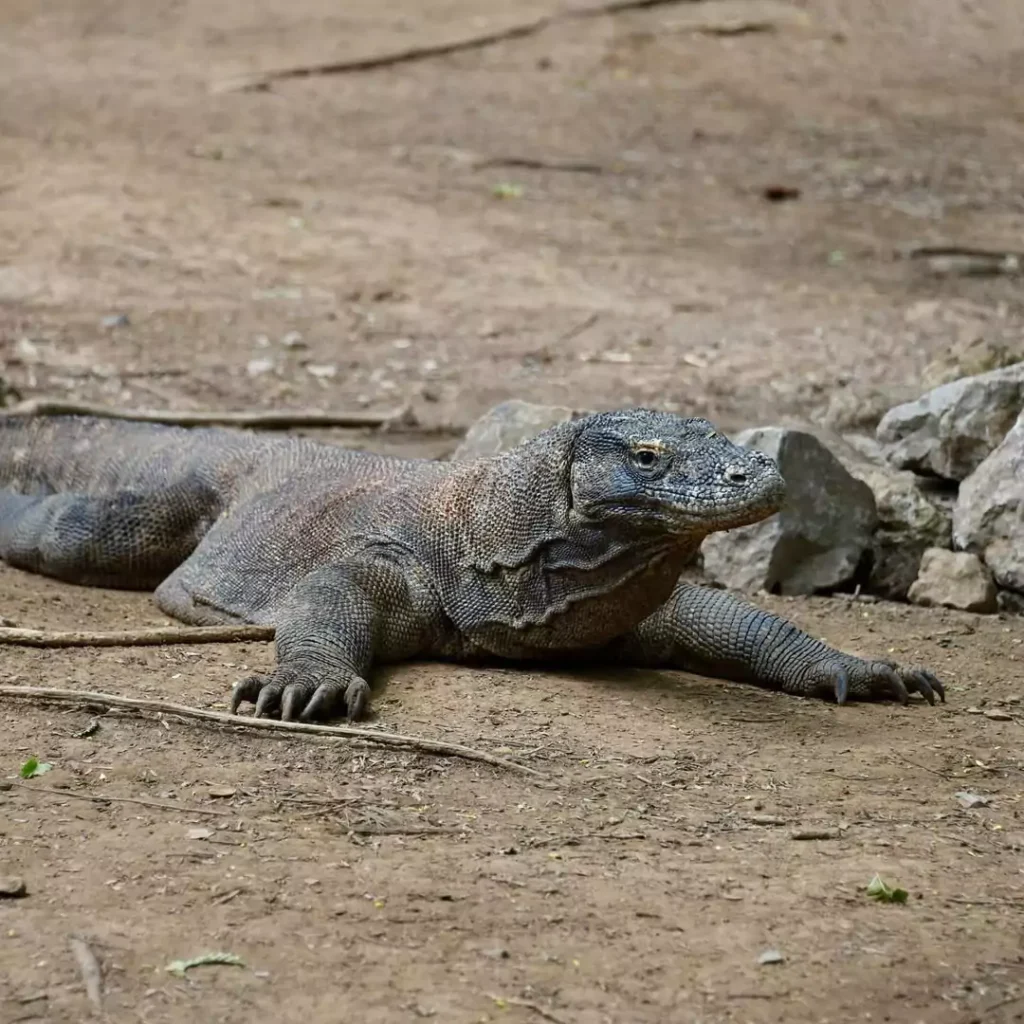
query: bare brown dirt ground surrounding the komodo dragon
0 0 1024 1024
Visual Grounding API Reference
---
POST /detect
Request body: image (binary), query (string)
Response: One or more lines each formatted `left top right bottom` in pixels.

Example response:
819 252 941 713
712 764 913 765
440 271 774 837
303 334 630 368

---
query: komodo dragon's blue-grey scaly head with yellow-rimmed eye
570 409 784 542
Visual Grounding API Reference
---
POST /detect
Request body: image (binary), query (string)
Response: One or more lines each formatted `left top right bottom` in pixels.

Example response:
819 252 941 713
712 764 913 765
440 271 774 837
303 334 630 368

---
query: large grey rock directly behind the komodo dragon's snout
702 427 878 594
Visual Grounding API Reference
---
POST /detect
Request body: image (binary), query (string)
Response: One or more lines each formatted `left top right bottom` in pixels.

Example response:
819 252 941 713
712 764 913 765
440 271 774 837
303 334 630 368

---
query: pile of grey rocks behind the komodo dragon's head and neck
455 362 1024 612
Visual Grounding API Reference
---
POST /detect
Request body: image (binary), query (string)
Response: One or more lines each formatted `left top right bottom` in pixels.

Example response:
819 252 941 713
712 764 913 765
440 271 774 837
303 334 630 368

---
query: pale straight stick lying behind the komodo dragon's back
4 398 416 430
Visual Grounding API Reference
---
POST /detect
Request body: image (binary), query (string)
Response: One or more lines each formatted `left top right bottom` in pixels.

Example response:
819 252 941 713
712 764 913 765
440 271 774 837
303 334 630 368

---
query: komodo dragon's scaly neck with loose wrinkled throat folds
407 422 702 653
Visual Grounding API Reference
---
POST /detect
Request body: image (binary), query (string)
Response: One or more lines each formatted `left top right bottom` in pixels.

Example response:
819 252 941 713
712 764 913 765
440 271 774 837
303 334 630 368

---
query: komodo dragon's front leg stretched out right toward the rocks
620 582 946 705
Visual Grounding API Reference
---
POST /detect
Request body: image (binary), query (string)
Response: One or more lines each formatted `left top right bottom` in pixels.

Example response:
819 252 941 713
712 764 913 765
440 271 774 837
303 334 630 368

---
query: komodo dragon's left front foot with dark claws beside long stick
231 662 370 722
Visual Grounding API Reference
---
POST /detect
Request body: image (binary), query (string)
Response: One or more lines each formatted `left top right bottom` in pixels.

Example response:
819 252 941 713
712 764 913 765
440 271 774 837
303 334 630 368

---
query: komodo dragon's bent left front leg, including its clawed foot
231 556 444 721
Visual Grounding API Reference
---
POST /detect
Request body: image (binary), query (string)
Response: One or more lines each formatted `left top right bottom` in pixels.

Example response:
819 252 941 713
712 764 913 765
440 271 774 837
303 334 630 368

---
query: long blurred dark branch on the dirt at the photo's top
212 0 700 92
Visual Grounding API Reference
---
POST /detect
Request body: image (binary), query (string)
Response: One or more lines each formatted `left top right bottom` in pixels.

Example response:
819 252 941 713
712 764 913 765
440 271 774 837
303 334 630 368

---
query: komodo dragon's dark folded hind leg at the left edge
0 481 219 590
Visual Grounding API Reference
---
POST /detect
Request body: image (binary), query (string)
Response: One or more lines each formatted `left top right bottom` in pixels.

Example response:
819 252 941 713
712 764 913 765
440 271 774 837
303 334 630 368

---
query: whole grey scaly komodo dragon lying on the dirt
0 410 945 721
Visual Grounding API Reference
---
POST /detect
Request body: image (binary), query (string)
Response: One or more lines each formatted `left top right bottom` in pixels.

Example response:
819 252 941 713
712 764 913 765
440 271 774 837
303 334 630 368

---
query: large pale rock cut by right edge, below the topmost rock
953 413 1024 594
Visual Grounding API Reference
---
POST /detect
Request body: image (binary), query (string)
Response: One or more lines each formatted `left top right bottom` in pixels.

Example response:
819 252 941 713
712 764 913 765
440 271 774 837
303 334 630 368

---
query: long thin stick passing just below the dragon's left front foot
0 686 544 778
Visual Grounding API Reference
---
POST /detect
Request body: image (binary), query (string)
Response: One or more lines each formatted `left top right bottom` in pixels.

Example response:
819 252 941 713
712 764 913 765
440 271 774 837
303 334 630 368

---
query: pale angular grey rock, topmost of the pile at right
877 362 1024 480
